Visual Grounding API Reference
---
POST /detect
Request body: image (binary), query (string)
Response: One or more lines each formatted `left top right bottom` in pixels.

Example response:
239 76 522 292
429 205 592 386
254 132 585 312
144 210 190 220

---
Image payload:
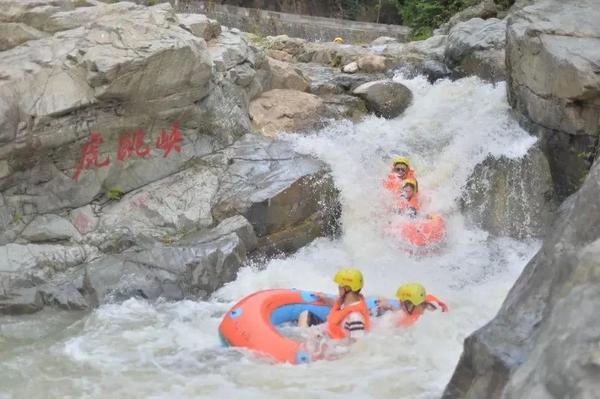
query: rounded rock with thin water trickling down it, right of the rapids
461 147 556 239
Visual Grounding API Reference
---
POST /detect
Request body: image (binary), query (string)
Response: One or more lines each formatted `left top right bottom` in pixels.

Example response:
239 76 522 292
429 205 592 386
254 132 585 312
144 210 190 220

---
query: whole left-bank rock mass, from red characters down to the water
0 0 338 313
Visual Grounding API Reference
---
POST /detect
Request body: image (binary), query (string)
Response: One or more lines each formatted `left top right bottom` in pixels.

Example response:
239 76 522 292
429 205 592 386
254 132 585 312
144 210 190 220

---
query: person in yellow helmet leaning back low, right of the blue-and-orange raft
377 283 448 327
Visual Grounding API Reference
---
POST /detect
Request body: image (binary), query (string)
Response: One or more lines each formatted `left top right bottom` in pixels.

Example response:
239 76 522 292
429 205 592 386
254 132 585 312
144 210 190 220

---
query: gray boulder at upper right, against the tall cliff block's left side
445 18 506 82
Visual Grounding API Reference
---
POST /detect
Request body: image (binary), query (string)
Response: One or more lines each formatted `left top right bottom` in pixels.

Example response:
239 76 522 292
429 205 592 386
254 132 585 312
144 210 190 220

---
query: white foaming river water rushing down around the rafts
0 76 539 399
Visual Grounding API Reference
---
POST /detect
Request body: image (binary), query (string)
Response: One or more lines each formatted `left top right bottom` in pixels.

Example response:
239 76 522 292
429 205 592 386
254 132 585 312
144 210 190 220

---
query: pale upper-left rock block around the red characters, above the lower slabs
0 4 217 214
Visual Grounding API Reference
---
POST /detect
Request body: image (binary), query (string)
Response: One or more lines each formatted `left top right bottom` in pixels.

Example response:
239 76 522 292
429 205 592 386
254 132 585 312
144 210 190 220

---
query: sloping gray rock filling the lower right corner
443 158 600 399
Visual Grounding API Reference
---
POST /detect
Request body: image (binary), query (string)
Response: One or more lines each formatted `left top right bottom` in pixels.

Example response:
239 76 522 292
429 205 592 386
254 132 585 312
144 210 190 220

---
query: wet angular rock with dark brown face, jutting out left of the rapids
213 136 339 250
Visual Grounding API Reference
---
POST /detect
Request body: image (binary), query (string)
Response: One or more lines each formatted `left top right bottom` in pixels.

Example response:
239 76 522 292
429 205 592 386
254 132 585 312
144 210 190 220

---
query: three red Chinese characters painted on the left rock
73 123 183 181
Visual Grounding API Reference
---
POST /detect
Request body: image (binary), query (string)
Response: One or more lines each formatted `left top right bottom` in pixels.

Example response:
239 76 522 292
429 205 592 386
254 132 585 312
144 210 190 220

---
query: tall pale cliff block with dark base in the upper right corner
506 0 600 198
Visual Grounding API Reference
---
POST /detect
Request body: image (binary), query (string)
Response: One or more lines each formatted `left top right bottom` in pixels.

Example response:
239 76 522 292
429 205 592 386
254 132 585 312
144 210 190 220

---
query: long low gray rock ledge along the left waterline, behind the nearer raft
85 222 251 304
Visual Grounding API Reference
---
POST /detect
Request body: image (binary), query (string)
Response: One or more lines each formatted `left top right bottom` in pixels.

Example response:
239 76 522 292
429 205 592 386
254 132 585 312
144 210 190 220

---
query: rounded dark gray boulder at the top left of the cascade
352 80 412 119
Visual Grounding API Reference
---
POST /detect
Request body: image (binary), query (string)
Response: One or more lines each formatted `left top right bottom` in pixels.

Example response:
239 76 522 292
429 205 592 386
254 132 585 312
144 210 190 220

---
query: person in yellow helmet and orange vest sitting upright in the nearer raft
298 268 371 340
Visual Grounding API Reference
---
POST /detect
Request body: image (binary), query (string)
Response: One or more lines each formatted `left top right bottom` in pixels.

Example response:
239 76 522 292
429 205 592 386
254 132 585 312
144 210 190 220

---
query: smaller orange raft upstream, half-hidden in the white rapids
385 213 446 249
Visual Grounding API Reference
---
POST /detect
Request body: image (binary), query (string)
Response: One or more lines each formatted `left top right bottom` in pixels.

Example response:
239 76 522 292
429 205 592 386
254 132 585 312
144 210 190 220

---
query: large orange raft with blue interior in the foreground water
219 289 400 364
